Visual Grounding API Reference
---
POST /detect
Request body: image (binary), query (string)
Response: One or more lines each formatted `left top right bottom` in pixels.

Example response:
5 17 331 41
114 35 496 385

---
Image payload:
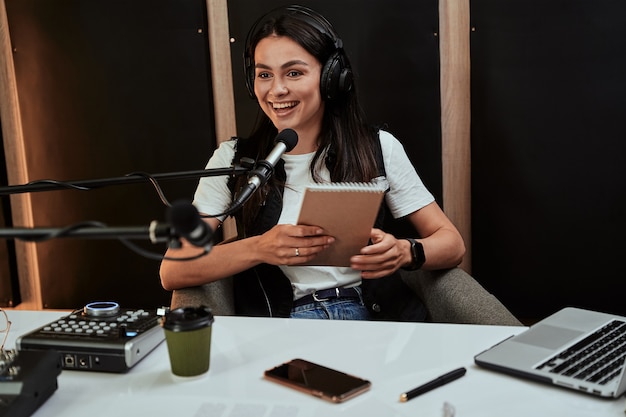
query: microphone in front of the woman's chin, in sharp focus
229 129 298 213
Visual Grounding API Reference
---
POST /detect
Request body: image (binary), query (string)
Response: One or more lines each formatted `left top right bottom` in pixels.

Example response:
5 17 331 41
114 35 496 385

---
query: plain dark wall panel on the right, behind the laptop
471 0 626 318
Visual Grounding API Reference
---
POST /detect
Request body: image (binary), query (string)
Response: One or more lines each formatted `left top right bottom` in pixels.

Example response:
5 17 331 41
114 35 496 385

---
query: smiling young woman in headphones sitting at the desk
161 6 465 320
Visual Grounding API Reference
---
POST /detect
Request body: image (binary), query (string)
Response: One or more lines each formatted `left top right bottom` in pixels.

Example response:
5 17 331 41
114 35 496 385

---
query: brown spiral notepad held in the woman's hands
298 183 385 266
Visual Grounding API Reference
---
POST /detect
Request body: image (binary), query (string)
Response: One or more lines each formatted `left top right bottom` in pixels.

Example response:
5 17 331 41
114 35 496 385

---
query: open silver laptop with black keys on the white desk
474 307 626 398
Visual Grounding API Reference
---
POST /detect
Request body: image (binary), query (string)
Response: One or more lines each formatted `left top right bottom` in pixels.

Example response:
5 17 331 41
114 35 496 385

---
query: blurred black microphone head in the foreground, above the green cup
167 201 213 249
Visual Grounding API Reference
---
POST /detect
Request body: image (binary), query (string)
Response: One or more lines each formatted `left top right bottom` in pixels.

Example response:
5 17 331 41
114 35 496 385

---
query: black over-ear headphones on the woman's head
243 5 353 100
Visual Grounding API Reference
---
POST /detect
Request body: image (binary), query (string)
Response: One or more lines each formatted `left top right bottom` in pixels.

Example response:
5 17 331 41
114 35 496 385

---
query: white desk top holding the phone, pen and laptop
7 311 626 417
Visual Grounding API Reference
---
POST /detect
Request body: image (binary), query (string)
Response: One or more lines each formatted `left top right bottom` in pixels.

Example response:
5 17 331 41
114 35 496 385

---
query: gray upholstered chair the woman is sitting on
170 268 522 326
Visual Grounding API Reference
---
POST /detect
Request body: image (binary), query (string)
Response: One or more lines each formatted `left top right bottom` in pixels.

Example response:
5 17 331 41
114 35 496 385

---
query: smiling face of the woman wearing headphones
254 35 324 153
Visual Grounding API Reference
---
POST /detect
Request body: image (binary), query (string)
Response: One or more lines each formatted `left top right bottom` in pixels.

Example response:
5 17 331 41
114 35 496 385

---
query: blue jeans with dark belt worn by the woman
290 293 370 320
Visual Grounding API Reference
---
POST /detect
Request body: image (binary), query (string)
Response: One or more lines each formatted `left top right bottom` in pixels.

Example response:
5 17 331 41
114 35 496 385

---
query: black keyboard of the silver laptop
537 320 626 385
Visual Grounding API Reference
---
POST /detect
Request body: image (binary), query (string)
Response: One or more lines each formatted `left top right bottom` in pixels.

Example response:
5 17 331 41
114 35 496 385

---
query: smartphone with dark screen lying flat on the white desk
264 359 372 403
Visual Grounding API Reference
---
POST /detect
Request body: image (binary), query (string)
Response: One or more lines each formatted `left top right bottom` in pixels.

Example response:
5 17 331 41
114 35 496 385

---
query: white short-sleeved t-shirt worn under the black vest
194 130 435 299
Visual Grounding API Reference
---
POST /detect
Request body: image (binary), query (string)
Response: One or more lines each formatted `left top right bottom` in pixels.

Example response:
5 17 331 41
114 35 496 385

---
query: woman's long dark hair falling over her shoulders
230 6 378 229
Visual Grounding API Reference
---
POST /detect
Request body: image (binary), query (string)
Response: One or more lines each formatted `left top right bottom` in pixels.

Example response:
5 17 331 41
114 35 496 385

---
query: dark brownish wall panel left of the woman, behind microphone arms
6 0 215 308
